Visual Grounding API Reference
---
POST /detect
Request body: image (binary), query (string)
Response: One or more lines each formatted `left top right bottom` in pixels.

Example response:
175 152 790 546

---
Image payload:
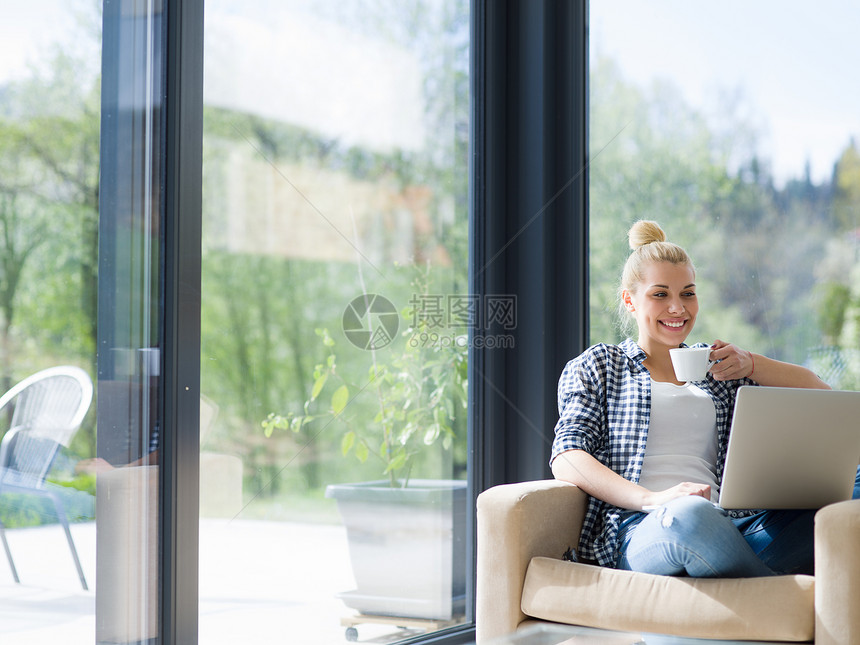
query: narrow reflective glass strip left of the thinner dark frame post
97 0 164 643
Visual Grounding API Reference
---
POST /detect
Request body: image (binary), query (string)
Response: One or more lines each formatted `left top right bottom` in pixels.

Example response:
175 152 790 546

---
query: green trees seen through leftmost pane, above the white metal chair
0 44 100 454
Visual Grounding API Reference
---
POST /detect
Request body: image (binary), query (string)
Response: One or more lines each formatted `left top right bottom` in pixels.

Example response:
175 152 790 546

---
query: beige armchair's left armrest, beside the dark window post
476 479 587 643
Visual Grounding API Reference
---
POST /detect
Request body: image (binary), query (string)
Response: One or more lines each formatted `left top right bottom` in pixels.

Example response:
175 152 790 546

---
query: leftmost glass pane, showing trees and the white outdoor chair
0 0 101 644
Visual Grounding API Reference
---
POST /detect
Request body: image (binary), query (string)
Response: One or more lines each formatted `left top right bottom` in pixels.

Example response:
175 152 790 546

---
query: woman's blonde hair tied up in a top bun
618 220 696 333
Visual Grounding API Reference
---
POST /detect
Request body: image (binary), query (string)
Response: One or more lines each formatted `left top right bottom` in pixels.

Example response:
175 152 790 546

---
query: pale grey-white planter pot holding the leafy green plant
326 480 466 620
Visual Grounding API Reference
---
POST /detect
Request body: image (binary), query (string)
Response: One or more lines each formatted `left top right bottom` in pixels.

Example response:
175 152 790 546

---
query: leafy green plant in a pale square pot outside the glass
263 294 467 620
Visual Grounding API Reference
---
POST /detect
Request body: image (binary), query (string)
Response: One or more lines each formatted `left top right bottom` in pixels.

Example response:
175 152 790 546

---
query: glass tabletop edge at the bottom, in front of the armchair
489 624 796 645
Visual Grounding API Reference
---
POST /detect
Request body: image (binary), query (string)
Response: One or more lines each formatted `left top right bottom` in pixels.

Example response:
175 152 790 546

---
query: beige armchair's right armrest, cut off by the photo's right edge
815 499 860 645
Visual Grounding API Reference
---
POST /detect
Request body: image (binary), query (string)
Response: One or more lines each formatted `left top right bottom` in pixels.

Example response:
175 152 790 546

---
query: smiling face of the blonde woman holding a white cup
622 262 699 355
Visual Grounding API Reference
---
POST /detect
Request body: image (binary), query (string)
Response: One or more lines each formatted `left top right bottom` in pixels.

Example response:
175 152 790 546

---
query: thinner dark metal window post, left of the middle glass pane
159 0 204 645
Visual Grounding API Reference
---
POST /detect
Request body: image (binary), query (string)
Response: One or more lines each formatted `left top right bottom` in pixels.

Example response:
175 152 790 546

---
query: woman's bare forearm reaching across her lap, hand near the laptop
552 450 711 511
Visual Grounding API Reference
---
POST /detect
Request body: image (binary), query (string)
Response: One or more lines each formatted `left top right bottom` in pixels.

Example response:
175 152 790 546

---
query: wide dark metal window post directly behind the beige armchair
469 0 588 490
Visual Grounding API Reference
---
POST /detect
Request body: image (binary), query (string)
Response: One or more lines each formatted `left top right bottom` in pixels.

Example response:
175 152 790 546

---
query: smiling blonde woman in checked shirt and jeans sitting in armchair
551 221 840 577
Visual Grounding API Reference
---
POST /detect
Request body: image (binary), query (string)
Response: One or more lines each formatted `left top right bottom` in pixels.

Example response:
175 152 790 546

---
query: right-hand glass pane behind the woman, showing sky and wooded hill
590 0 860 389
